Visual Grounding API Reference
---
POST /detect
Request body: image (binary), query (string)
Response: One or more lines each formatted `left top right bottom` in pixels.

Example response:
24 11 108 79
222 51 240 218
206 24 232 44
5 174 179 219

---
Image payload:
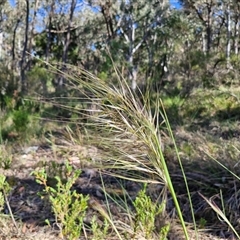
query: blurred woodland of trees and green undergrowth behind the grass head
0 0 240 139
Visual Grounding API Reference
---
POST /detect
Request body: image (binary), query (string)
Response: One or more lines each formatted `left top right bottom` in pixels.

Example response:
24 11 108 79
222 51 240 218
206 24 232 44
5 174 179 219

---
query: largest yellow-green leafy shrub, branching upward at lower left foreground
33 163 89 240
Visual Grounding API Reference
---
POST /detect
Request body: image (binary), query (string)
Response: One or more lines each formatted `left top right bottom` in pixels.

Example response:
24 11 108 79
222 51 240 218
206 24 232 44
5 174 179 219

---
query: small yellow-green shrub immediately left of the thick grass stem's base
133 184 169 239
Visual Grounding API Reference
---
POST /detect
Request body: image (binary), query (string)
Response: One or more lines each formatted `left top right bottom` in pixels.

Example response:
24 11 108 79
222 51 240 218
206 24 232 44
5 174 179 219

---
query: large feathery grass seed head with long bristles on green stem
46 62 189 239
